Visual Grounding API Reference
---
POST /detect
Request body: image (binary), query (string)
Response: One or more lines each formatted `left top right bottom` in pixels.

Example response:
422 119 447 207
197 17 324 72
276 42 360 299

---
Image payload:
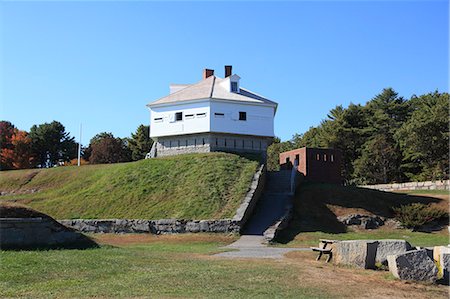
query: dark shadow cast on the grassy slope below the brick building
277 183 441 244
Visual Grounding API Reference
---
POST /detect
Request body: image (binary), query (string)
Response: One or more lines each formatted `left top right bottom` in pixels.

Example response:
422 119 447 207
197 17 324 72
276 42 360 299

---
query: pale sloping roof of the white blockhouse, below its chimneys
147 76 278 107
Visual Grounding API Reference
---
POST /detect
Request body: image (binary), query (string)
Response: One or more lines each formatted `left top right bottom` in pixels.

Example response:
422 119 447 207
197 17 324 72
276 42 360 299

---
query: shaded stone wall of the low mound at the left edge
0 218 96 249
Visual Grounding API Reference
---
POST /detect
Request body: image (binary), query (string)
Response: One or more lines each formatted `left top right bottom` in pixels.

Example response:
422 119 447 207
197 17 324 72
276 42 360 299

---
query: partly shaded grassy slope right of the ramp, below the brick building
278 184 450 247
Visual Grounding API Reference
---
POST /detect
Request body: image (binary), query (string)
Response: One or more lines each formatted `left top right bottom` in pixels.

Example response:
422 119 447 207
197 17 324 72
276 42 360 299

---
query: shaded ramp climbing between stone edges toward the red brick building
243 170 291 236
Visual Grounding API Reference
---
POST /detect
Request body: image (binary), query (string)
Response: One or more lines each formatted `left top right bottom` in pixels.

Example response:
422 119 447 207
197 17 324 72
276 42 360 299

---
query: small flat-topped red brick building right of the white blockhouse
279 147 342 184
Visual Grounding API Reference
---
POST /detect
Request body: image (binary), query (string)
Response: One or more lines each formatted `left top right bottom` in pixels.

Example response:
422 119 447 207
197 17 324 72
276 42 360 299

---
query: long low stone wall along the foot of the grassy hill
58 219 240 234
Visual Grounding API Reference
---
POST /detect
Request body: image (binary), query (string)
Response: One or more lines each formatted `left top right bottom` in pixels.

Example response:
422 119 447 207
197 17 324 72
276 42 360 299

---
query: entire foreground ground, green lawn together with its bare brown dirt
0 234 447 298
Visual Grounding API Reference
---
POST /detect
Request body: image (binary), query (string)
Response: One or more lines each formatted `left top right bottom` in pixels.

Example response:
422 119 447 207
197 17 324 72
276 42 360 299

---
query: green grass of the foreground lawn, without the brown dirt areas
0 236 331 298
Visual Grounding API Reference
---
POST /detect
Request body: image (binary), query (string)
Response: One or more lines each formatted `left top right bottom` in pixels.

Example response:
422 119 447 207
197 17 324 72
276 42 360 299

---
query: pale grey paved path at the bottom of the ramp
216 235 311 259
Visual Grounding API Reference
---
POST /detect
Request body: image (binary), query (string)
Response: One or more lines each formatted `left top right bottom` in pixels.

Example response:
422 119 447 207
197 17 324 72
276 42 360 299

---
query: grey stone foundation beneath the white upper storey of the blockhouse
156 133 271 157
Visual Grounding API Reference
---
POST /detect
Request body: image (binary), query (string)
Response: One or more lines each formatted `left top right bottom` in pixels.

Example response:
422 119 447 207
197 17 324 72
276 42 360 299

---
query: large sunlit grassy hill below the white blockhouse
0 153 258 219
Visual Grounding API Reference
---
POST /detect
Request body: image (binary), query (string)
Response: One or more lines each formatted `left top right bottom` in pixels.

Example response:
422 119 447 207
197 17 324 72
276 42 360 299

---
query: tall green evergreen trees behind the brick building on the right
268 88 449 184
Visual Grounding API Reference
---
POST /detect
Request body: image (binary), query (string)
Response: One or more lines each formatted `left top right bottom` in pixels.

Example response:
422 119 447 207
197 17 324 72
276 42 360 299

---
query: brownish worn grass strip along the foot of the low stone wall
92 234 238 246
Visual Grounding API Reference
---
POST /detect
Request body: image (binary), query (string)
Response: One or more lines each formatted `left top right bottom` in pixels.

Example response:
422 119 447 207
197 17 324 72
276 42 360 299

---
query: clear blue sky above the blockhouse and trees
0 1 449 144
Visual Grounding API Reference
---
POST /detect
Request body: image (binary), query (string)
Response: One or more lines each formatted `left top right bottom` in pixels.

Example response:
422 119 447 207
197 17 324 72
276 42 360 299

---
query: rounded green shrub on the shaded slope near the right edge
393 203 447 229
